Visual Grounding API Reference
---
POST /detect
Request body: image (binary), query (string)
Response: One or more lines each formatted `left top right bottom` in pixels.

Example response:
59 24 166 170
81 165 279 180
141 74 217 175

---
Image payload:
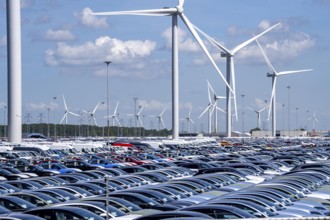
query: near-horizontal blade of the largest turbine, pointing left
92 8 177 16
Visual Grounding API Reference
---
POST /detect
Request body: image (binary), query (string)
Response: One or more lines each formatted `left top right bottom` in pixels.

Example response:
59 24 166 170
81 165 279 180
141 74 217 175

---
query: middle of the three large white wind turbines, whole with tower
194 23 280 137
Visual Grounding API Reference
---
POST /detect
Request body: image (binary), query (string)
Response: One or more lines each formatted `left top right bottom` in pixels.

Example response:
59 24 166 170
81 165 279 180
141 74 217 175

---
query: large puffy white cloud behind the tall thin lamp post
45 36 156 77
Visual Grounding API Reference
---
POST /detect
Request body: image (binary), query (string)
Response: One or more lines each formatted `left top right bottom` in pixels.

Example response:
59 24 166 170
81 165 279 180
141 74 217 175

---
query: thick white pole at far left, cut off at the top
7 0 22 143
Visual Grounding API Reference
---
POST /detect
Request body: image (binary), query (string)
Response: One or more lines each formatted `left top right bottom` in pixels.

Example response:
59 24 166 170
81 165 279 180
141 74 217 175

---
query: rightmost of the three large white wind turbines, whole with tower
256 40 312 137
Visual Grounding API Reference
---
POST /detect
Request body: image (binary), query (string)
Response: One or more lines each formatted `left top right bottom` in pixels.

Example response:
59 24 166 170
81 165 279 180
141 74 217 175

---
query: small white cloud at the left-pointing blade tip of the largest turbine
74 8 109 28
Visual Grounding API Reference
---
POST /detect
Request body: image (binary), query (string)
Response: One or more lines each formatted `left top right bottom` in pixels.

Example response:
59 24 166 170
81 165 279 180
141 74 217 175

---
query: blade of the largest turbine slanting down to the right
180 13 234 93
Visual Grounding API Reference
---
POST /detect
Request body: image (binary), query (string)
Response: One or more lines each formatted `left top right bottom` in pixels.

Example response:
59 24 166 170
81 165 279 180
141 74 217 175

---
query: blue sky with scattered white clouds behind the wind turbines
0 0 330 132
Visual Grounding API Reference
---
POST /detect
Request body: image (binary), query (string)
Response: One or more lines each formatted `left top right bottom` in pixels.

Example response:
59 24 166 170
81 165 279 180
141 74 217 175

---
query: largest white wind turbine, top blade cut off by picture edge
92 0 233 139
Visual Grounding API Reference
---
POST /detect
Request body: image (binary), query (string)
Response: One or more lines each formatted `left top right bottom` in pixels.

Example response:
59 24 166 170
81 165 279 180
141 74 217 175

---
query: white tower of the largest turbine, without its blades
172 14 179 139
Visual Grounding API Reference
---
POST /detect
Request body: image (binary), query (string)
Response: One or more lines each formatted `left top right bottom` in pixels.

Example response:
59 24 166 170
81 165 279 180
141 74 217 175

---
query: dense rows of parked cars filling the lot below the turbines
0 138 330 220
